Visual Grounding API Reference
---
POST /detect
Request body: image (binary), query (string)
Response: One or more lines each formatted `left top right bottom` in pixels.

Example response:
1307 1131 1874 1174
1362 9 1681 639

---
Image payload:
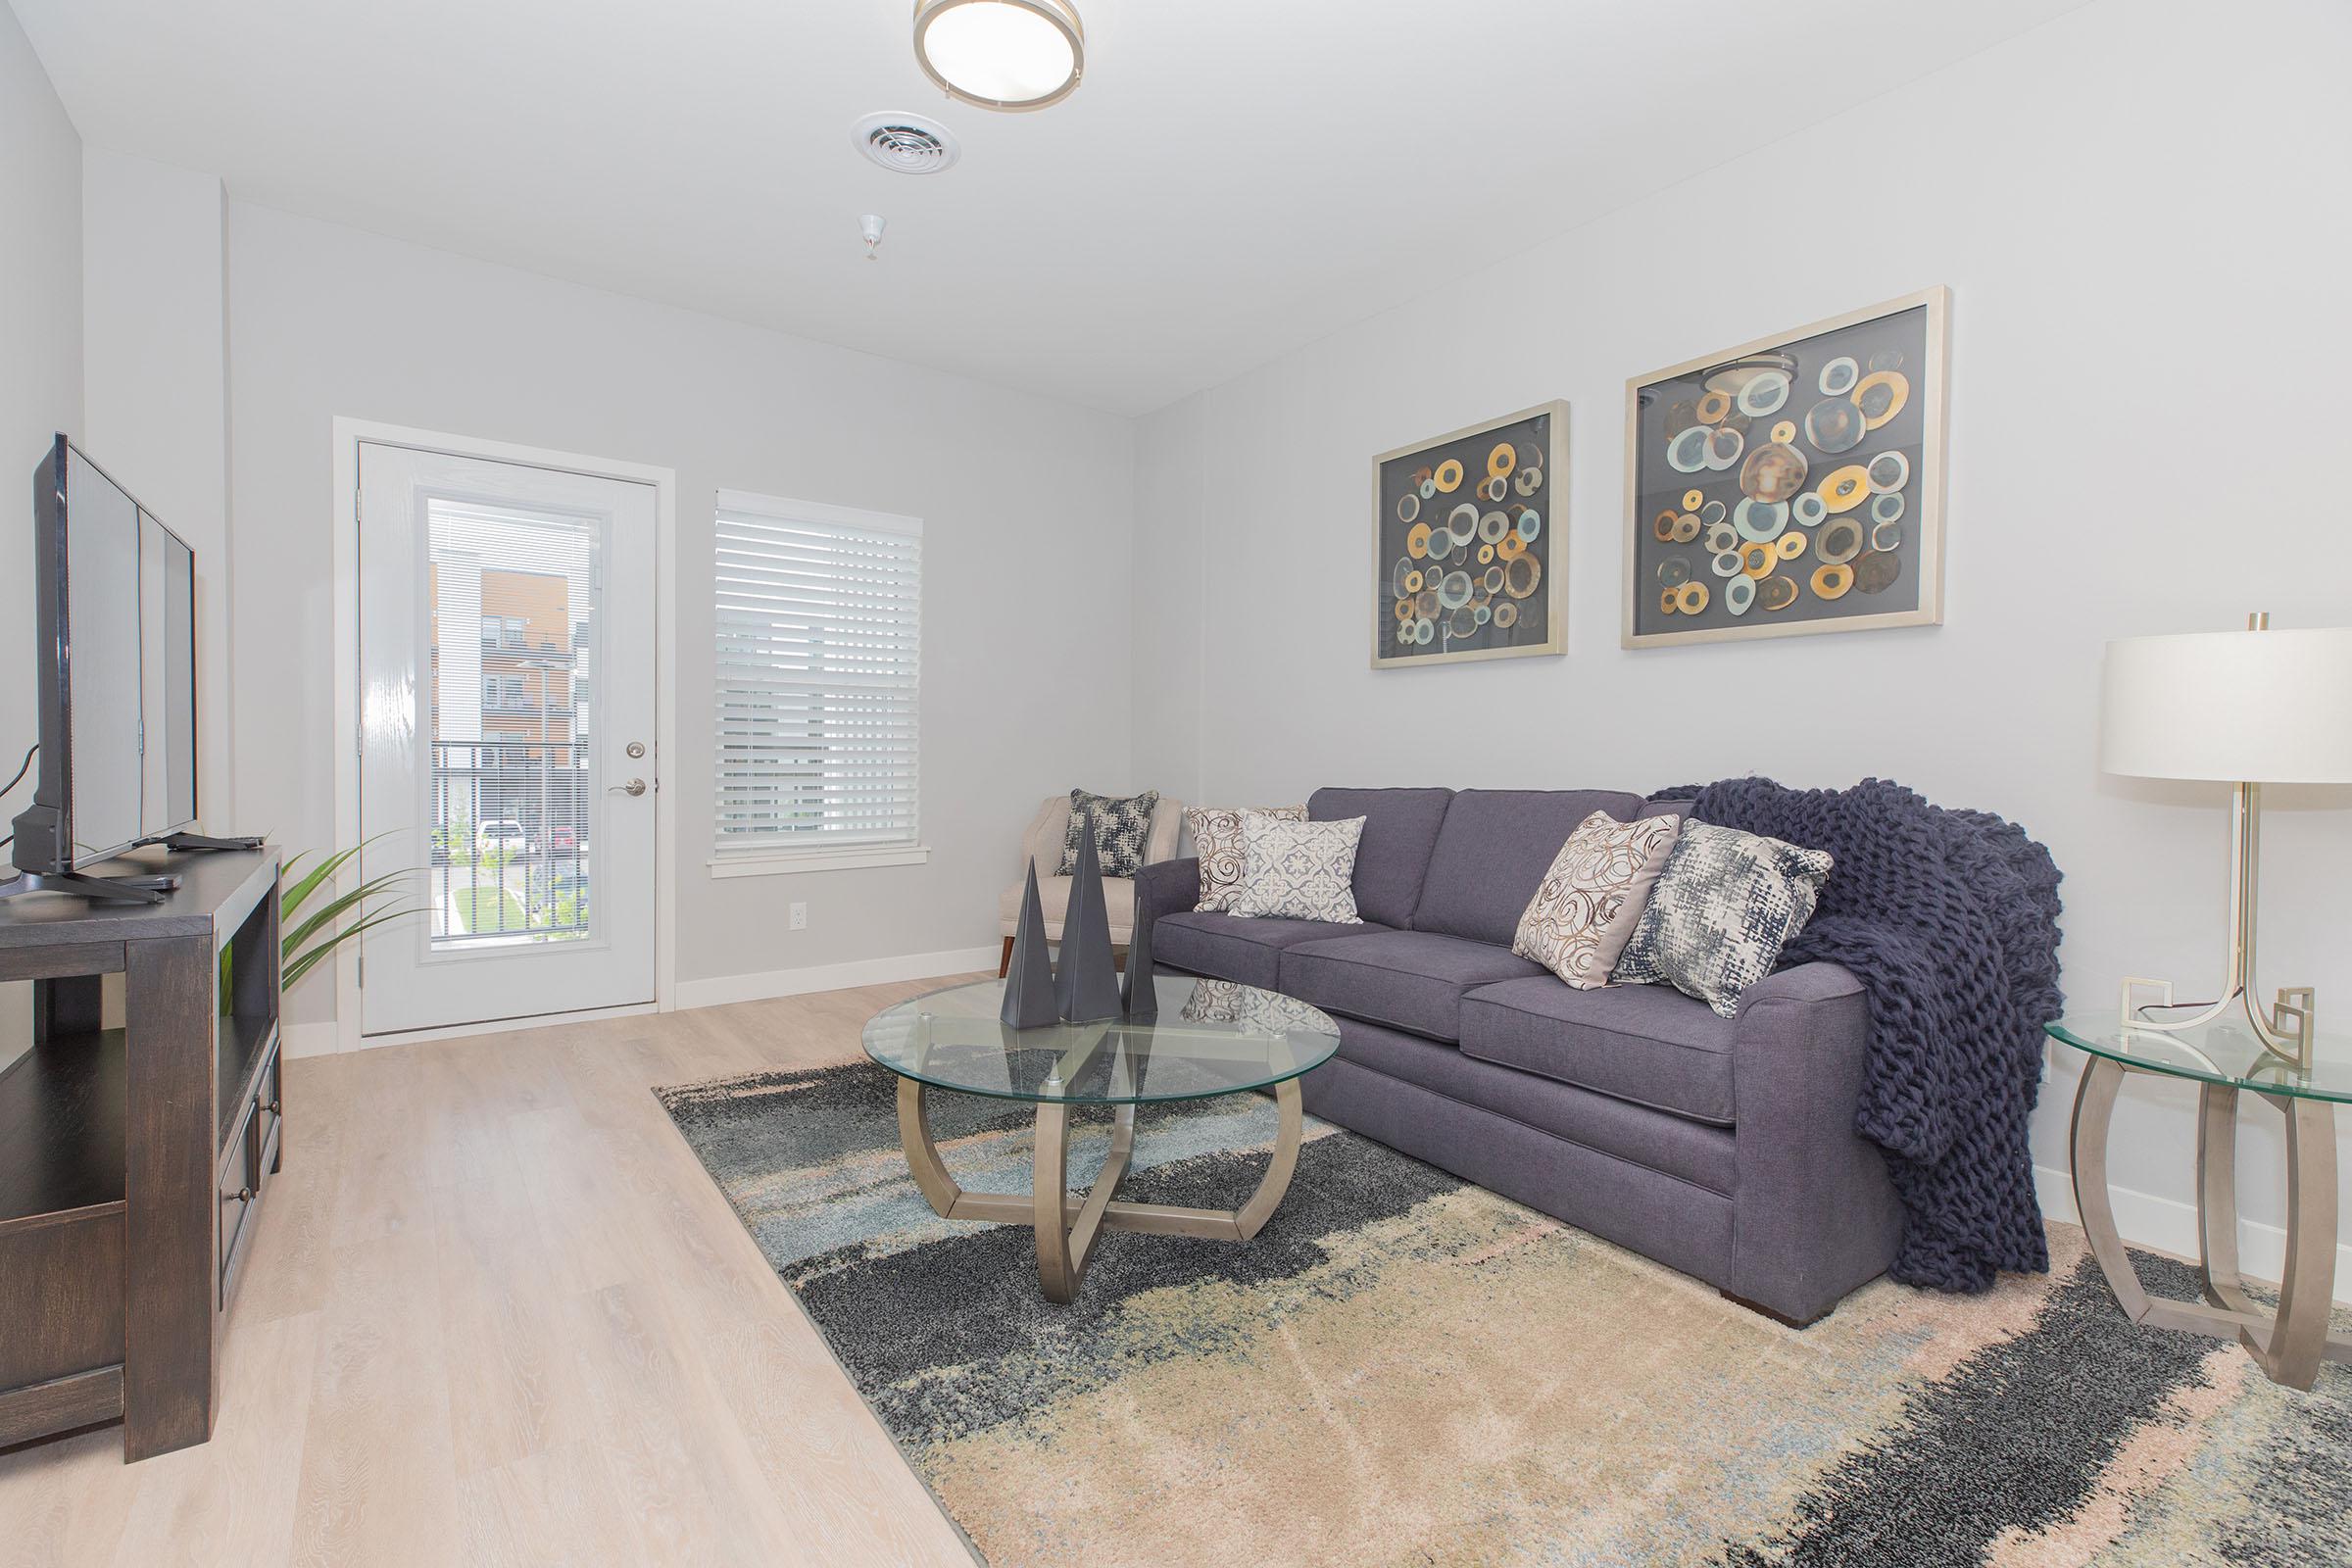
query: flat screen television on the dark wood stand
10 435 198 896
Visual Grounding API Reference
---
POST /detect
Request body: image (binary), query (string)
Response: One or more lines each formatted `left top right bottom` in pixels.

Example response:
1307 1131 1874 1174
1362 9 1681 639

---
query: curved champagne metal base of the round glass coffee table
899 1077 1300 1302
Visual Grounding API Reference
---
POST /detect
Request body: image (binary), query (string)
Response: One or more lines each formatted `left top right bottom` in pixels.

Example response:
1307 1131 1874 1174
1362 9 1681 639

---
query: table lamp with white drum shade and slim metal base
2098 613 2352 1072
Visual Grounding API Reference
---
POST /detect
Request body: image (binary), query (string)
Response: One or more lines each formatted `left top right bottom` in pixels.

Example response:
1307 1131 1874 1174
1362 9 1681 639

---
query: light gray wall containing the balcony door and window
228 202 1134 1022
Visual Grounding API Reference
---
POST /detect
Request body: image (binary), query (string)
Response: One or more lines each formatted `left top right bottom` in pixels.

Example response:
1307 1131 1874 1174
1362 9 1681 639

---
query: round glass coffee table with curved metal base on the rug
865 976 1339 1302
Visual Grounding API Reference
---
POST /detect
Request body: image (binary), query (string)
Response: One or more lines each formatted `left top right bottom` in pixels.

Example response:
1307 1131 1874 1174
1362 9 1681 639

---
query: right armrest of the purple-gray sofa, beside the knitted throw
1731 964 1903 1324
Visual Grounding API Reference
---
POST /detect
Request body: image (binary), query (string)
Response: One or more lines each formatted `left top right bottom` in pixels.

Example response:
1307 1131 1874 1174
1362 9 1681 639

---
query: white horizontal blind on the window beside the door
717 491 922 858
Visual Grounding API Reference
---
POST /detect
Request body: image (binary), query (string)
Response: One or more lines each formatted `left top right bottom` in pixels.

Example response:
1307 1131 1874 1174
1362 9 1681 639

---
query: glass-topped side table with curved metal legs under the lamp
2044 1013 2352 1390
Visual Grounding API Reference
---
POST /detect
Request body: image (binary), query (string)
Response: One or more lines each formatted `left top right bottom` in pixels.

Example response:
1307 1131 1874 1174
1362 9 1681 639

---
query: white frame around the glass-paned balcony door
334 414 677 1051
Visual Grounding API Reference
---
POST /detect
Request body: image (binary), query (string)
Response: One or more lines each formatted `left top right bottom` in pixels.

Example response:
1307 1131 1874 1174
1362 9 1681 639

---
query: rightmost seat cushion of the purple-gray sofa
1460 976 1739 1126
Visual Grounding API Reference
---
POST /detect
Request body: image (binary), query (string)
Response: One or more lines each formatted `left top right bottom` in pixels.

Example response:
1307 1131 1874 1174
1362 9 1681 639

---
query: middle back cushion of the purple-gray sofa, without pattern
1413 790 1642 948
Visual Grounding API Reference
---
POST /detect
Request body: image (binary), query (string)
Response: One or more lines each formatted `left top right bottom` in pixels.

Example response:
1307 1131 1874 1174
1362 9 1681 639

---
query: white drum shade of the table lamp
2098 627 2352 783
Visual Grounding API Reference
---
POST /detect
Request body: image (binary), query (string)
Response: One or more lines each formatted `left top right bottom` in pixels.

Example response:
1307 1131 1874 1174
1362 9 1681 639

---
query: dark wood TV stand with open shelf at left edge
0 849 282 1460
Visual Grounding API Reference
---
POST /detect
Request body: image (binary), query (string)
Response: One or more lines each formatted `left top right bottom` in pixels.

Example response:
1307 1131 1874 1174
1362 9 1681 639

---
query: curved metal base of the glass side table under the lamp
2079 1057 2352 1390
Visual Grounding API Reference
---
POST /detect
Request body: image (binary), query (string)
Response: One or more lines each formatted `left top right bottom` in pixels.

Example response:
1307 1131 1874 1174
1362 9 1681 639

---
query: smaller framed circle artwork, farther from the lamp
1371 400 1569 670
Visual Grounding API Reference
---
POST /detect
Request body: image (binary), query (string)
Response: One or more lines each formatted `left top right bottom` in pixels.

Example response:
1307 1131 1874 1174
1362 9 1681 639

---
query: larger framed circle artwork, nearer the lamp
1618 284 1950 649
